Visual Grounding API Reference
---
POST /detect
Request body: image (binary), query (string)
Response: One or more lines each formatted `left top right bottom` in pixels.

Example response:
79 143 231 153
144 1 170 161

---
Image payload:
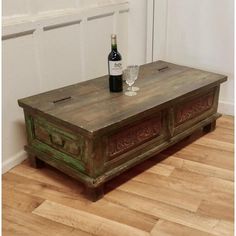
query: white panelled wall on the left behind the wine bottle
2 0 148 172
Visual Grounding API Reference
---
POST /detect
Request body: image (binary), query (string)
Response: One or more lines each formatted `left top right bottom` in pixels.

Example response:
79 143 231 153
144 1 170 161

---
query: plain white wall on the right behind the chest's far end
153 0 234 115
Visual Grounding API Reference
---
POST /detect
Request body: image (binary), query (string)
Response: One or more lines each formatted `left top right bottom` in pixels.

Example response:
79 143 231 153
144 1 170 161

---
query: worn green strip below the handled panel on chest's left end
32 140 85 172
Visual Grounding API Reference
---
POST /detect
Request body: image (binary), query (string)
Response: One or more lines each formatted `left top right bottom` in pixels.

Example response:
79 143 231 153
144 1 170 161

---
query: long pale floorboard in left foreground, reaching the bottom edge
33 200 149 236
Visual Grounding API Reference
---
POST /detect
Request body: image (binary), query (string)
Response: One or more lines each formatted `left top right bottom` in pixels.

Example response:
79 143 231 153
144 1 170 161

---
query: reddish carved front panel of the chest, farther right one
175 91 214 127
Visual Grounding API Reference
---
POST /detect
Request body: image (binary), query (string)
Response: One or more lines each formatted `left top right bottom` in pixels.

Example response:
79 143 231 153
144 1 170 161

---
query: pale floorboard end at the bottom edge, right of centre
150 220 213 236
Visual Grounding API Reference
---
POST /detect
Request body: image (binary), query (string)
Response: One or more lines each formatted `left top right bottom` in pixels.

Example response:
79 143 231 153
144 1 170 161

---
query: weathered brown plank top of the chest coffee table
18 61 226 134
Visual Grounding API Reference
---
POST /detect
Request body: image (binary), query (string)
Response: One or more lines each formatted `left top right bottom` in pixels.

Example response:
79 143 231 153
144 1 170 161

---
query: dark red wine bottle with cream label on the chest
108 34 123 92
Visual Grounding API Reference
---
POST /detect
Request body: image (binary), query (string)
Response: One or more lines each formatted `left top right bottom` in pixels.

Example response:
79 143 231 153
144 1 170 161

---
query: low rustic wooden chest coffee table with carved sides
18 61 227 201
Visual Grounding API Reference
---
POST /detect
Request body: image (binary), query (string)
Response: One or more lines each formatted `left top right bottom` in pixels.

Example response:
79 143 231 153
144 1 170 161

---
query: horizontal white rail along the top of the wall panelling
2 2 129 39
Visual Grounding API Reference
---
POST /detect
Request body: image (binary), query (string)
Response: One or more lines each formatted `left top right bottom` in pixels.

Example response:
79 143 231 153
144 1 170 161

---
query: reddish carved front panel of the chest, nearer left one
107 115 162 160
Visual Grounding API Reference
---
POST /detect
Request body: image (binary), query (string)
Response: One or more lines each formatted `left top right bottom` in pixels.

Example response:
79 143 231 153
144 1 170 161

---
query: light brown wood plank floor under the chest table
2 116 234 236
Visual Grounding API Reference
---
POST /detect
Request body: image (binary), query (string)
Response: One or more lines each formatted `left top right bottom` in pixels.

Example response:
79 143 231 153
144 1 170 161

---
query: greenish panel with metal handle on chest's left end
34 119 84 158
